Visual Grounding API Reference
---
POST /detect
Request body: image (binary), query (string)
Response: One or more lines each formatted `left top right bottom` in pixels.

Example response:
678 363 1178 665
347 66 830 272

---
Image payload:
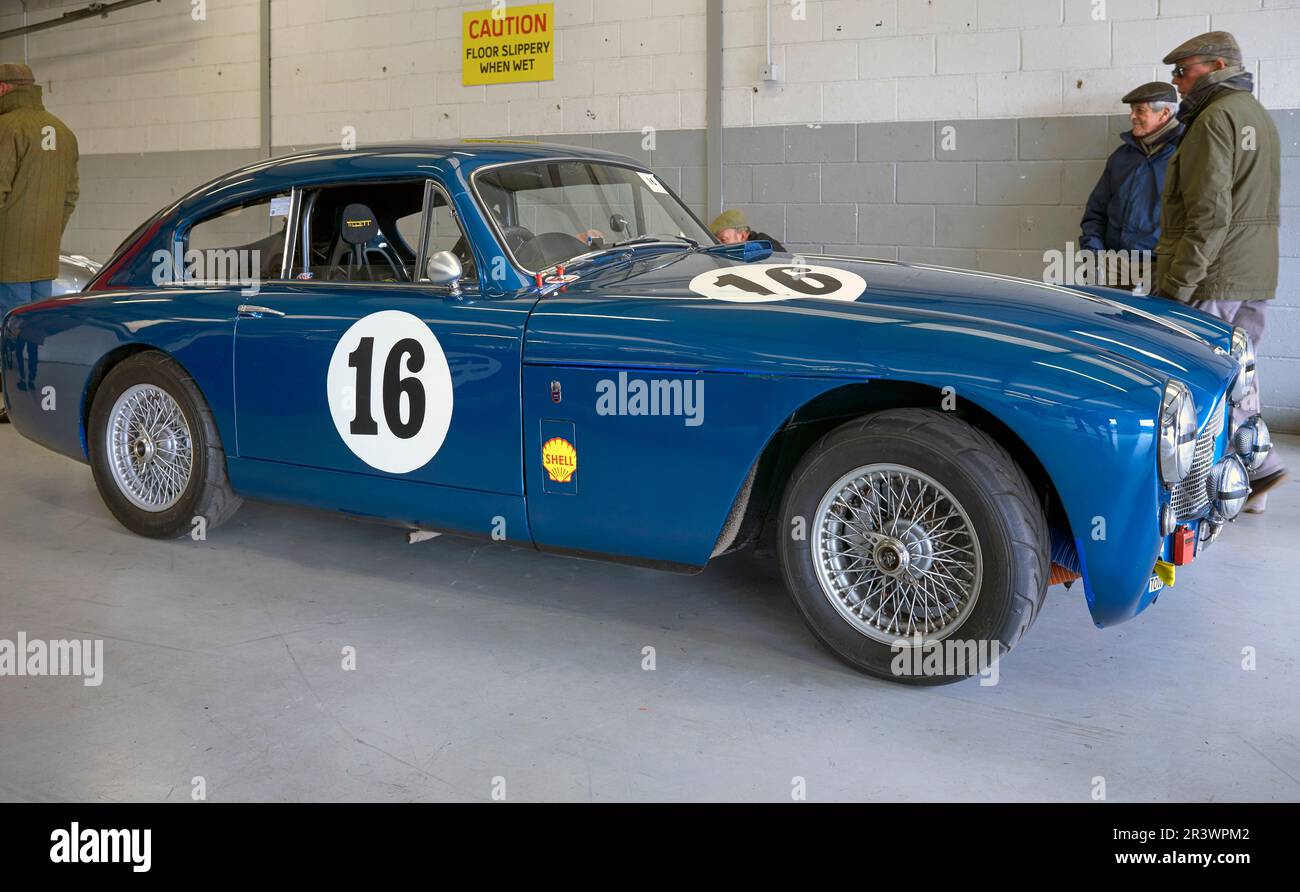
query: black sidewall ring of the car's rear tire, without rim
86 354 209 538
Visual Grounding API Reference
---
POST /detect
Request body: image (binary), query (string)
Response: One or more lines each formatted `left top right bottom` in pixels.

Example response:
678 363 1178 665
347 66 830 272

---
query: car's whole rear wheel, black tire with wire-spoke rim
86 351 242 538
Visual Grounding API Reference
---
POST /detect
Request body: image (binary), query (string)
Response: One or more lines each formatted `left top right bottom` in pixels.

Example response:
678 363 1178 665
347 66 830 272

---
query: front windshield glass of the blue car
475 161 714 272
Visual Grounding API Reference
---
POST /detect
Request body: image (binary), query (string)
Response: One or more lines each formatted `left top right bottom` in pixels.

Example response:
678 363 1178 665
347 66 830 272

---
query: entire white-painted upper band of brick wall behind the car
0 0 1300 153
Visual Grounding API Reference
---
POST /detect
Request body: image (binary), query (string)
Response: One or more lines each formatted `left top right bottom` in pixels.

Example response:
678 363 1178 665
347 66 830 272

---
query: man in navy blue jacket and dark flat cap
1079 81 1183 286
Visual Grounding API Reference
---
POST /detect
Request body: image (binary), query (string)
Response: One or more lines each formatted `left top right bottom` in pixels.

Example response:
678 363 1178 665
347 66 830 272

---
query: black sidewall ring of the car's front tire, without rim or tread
780 424 1017 684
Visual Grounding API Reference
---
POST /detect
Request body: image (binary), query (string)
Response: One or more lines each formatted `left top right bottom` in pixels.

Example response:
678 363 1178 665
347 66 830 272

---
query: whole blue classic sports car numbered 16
3 140 1269 683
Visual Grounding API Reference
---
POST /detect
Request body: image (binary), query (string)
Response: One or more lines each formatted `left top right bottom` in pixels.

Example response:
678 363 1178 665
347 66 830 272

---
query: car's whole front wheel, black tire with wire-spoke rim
780 410 1050 684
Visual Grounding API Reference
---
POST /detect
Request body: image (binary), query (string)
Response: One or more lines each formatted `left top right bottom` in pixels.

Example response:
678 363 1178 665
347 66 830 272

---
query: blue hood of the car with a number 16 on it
567 250 1235 416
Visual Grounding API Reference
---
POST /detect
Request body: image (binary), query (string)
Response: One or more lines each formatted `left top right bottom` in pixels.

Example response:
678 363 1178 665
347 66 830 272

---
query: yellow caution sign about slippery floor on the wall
460 3 555 87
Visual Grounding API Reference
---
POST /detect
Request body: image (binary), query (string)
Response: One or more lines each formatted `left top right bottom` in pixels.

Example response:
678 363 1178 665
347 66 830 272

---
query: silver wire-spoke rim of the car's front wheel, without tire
810 463 984 644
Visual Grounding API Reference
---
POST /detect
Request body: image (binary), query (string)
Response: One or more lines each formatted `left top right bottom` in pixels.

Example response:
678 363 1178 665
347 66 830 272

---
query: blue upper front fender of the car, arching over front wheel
525 294 1235 625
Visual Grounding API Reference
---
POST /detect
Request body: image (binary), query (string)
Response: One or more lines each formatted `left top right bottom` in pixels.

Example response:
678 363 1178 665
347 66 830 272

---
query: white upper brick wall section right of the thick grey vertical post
723 0 1300 124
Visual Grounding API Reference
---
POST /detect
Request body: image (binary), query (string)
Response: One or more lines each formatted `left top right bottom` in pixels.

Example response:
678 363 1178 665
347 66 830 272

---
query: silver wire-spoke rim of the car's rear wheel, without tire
105 384 194 514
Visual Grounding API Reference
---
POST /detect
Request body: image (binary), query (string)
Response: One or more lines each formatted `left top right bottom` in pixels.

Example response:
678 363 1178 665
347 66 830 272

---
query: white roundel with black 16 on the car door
325 309 451 473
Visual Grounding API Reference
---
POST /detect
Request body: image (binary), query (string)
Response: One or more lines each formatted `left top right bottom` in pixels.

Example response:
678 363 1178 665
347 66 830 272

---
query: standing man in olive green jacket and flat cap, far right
1156 31 1287 512
